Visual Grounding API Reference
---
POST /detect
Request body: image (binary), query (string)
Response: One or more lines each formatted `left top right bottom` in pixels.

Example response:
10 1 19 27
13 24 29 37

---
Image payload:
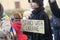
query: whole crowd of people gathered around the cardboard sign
0 0 60 40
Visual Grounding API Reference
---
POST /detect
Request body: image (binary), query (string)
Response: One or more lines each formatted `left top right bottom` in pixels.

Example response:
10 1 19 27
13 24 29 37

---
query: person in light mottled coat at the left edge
0 3 11 40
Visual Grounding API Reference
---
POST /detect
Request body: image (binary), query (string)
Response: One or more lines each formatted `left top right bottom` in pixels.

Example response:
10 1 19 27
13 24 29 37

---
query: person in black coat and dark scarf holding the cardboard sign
25 0 52 40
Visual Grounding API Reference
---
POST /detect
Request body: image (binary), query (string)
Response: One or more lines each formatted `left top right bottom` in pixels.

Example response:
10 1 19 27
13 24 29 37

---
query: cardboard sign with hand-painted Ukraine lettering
21 20 45 34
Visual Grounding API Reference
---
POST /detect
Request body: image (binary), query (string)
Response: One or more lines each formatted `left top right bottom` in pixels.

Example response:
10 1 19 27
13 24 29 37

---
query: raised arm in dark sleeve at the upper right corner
49 0 60 18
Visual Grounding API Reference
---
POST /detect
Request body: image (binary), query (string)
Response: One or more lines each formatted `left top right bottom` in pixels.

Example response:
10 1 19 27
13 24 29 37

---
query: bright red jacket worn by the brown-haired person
12 22 28 40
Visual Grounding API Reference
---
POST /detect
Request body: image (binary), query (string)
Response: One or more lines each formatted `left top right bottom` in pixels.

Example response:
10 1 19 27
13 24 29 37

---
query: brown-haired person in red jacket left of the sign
12 13 28 40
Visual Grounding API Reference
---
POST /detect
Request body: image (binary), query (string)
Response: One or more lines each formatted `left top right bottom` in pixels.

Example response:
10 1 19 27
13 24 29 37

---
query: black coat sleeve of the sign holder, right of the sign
41 14 52 37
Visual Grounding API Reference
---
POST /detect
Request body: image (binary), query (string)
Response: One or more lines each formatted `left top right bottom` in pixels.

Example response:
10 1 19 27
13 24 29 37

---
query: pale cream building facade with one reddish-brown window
0 0 30 10
